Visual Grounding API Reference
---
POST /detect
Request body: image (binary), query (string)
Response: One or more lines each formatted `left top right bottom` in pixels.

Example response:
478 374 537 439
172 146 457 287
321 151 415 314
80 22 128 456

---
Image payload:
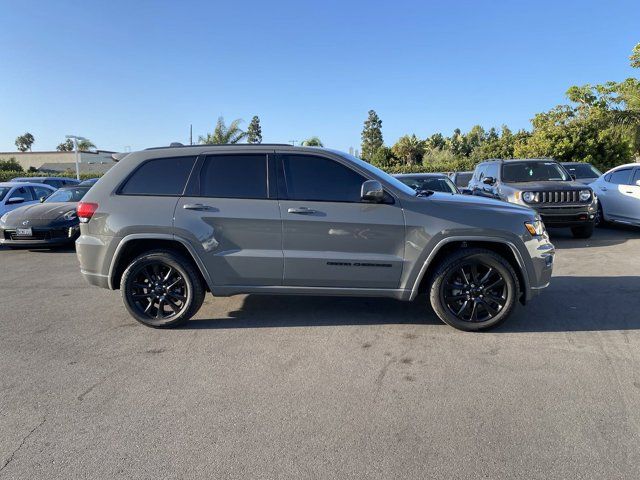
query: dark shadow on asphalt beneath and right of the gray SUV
182 276 640 333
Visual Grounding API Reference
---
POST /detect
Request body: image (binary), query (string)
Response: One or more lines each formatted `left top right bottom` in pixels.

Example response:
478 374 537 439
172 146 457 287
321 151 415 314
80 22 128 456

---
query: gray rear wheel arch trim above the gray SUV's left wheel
109 234 212 291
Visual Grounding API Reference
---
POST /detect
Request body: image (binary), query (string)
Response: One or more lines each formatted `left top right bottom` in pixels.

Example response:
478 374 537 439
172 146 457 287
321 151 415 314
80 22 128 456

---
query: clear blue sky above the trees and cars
0 0 640 151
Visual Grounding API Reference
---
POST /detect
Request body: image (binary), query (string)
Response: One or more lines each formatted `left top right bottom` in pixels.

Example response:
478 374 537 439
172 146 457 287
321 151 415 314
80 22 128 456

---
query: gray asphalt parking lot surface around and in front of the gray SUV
0 228 640 479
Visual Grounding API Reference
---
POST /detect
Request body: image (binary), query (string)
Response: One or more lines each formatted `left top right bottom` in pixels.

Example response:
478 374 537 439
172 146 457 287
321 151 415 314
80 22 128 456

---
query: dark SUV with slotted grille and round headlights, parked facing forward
469 159 598 238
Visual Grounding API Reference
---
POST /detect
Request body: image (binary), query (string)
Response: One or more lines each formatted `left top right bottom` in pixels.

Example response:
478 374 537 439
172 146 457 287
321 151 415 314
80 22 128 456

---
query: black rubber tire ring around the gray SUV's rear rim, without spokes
120 253 194 328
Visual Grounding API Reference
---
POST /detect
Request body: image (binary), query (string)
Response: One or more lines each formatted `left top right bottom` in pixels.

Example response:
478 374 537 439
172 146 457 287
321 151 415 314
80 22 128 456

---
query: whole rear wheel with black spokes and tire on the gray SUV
120 250 205 328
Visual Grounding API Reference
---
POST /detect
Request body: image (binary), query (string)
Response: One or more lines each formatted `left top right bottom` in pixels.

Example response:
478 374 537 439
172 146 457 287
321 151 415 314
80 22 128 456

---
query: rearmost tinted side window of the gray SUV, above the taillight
120 157 196 195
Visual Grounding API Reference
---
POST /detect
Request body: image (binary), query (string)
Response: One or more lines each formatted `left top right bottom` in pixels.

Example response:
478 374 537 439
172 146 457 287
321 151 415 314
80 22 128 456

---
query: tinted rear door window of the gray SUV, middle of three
200 154 267 199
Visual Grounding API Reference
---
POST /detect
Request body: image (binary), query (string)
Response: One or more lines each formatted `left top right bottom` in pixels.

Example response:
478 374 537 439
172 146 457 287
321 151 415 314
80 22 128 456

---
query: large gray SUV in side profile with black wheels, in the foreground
76 144 554 330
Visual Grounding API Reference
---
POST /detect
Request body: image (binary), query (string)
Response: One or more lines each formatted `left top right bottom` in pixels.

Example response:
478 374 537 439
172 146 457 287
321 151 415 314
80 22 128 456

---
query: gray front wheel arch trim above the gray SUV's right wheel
410 237 530 303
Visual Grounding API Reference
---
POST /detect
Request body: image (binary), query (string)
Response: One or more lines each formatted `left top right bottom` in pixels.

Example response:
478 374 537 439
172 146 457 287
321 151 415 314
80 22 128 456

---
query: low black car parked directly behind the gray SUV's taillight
0 186 90 247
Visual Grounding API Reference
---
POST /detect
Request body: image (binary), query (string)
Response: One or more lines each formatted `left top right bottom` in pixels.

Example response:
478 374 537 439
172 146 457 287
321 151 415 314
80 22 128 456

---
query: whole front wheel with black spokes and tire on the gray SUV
429 248 520 332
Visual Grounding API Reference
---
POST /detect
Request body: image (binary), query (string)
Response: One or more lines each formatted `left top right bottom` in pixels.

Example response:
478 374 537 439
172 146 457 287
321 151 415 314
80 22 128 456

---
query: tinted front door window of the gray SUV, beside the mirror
282 155 366 202
